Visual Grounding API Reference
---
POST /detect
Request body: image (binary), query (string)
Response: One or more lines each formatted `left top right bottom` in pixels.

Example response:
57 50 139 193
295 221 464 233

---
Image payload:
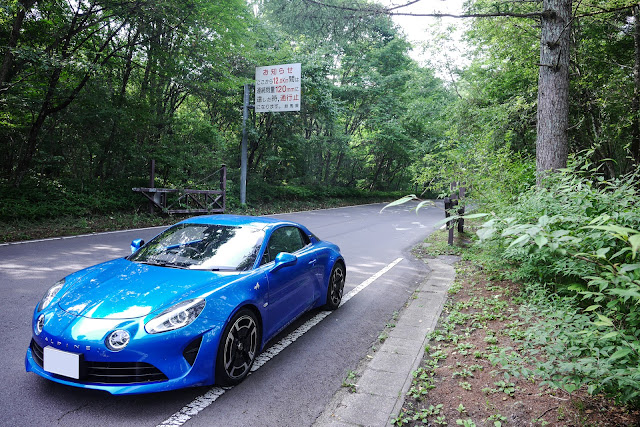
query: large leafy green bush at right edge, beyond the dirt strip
478 160 640 404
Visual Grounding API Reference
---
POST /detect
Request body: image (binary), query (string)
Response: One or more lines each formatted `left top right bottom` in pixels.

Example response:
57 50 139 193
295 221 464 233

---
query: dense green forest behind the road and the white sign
0 0 640 221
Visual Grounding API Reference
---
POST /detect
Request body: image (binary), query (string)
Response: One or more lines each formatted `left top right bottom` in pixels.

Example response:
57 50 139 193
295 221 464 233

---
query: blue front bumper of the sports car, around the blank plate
25 314 223 394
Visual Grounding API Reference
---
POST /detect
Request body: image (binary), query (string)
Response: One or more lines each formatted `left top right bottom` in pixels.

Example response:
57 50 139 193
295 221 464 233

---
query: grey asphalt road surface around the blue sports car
0 204 443 426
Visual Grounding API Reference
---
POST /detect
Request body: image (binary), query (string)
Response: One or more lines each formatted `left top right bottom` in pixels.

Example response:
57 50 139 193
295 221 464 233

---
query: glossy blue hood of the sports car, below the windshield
58 258 238 319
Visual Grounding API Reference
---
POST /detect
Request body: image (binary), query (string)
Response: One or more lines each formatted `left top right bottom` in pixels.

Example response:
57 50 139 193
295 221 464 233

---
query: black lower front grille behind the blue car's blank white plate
31 340 168 384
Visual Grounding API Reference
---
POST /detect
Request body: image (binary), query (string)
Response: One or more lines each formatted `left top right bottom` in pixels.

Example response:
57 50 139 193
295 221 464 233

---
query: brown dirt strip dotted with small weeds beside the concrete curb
395 256 640 427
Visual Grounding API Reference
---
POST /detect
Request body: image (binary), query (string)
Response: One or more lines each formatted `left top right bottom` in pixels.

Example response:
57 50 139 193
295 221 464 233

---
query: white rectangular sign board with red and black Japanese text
255 63 302 113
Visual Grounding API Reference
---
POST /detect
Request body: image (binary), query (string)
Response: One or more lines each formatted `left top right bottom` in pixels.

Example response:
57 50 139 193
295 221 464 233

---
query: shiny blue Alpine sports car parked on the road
25 215 346 394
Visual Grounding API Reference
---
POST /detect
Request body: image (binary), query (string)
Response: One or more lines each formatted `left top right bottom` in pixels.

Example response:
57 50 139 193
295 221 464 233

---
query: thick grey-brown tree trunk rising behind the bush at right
536 0 571 183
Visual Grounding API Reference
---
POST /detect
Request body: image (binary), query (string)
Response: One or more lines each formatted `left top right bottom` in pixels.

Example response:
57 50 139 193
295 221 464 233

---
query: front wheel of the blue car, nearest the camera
216 308 260 386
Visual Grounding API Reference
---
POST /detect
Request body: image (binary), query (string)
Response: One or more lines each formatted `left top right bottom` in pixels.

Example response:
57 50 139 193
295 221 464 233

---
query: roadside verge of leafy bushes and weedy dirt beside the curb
393 157 640 426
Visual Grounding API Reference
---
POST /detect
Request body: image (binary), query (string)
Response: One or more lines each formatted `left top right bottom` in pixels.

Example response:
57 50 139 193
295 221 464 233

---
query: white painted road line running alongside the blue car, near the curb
157 258 402 427
